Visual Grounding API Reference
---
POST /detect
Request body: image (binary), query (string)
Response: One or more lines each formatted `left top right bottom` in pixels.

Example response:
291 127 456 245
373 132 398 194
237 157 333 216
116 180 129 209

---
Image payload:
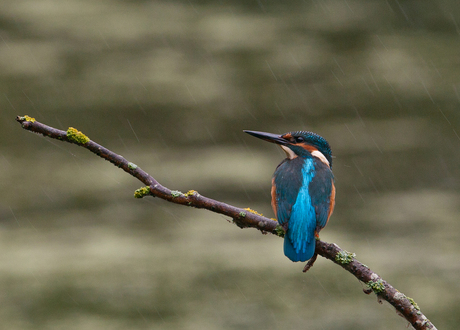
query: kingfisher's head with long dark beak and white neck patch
244 131 332 168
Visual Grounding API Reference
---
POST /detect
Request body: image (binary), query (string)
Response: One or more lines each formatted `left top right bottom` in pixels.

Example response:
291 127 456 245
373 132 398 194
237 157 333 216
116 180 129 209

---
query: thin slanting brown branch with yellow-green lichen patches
16 116 436 330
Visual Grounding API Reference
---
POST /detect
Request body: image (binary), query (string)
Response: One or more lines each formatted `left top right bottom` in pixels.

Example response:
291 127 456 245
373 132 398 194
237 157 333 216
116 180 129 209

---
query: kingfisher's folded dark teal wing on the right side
309 161 335 229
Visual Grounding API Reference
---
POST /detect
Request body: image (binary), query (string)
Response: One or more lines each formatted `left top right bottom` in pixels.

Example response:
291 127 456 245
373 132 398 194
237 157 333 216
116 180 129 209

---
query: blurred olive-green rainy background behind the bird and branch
0 0 460 330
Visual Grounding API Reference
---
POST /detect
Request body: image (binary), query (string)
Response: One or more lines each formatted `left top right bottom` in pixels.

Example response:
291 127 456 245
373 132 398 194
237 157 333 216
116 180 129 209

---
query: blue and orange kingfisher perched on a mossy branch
244 130 335 262
